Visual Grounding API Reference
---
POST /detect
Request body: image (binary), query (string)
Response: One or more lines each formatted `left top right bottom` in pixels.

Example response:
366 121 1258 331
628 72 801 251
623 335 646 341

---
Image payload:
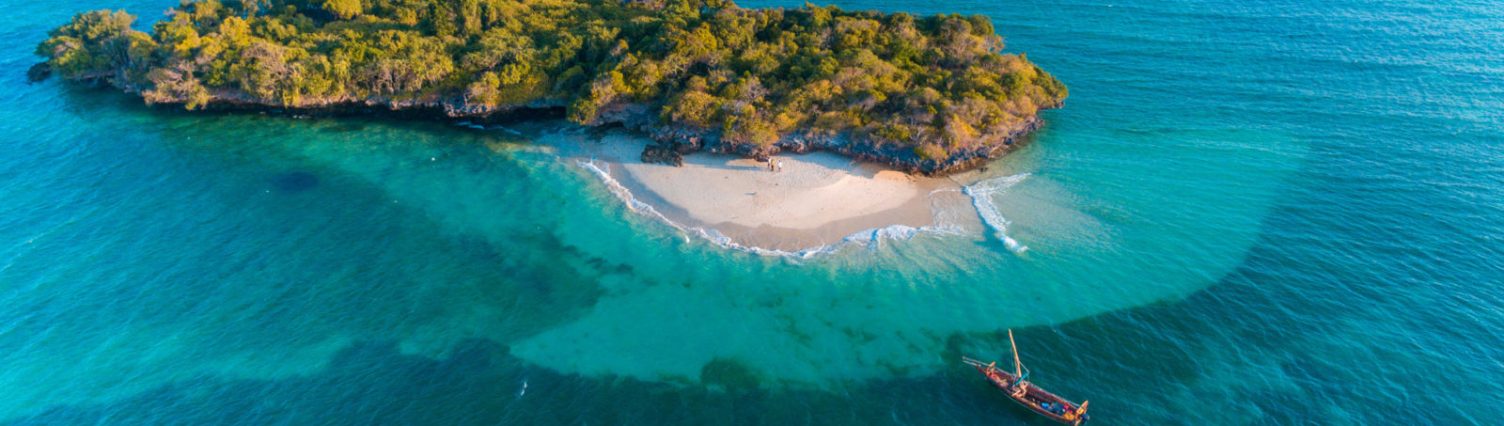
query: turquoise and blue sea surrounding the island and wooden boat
0 0 1504 424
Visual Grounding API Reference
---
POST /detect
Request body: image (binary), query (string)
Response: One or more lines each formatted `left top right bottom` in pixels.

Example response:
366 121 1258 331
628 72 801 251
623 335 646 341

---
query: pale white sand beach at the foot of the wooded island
561 132 966 250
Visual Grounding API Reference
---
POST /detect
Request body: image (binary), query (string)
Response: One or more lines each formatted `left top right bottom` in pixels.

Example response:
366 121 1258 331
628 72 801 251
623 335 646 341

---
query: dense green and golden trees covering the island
38 0 1066 172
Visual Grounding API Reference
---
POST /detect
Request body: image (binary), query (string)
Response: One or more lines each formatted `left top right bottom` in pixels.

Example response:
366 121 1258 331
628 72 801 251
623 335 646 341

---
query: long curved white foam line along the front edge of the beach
575 158 961 259
